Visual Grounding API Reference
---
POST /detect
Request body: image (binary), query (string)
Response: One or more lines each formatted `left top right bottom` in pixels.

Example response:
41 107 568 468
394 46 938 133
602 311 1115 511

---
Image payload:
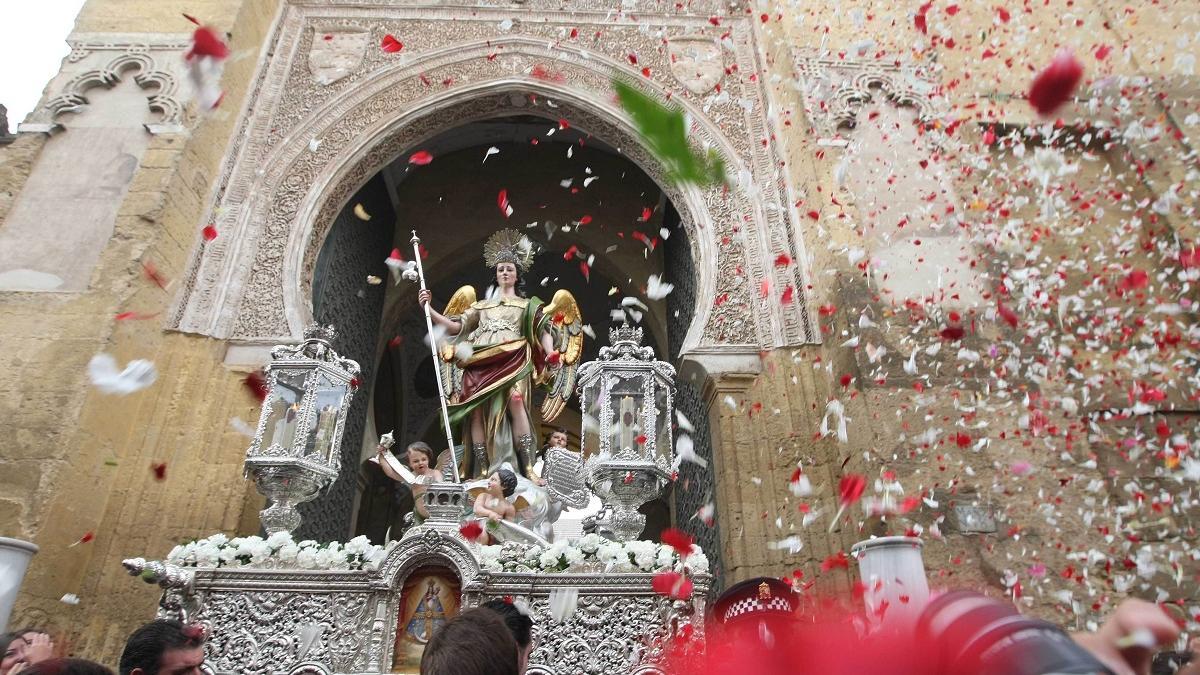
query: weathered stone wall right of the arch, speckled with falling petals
744 2 1200 627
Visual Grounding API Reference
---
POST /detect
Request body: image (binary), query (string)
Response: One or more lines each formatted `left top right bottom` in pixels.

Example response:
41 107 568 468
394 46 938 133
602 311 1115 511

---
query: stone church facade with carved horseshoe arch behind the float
0 0 1200 655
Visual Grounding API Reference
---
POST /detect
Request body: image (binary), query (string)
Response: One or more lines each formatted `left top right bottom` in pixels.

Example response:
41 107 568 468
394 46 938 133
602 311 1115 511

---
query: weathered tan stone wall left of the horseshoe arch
0 0 277 662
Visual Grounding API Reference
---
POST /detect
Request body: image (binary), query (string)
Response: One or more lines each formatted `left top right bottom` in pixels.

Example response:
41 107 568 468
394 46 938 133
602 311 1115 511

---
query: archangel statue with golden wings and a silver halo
418 229 583 479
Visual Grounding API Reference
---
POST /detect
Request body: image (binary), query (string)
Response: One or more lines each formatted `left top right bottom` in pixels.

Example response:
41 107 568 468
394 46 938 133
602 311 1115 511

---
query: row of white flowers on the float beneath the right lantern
479 533 708 574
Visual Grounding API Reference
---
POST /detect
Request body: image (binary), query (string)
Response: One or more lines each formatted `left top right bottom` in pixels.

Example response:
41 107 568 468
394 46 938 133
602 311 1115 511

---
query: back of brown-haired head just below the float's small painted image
421 608 520 675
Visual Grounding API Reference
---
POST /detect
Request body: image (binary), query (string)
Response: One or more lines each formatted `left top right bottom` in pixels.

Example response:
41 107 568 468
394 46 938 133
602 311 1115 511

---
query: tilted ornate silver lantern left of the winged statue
245 323 359 534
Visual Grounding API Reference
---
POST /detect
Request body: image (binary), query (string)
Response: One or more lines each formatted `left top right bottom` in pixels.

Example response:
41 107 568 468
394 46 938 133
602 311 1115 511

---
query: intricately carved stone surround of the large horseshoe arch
168 1 818 352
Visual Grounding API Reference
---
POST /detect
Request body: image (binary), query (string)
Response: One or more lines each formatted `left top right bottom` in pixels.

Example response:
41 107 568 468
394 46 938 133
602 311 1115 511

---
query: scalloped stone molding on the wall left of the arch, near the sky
20 34 191 133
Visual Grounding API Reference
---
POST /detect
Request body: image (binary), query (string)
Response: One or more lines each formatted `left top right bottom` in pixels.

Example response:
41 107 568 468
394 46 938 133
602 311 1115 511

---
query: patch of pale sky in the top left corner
0 0 85 124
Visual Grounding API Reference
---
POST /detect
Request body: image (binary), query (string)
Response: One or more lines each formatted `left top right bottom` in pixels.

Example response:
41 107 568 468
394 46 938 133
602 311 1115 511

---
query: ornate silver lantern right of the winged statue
578 324 676 540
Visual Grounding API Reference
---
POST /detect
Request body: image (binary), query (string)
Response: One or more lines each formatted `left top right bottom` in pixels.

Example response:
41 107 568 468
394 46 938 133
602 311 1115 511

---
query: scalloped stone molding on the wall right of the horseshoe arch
792 49 944 140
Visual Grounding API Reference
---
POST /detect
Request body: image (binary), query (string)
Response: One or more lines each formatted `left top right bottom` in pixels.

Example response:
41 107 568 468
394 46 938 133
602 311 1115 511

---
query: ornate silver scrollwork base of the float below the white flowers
132 524 710 675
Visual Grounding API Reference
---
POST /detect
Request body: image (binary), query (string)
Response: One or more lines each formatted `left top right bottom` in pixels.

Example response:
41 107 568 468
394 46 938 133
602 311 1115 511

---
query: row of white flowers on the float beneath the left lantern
167 532 395 571
